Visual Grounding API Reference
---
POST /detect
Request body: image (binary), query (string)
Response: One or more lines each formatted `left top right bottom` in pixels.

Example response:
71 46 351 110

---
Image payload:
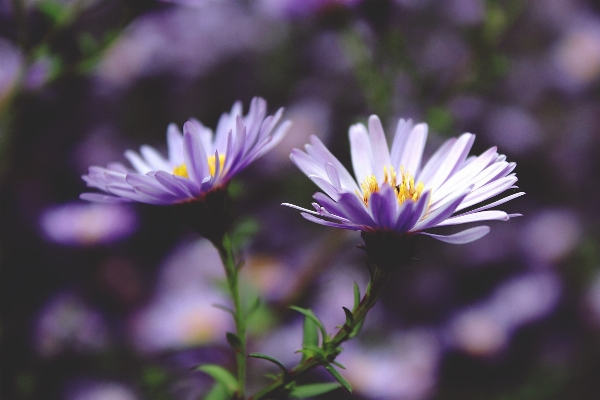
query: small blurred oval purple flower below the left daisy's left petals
40 203 138 246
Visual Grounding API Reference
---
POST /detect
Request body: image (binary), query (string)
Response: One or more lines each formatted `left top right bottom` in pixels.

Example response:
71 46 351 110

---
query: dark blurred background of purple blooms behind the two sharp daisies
0 0 600 400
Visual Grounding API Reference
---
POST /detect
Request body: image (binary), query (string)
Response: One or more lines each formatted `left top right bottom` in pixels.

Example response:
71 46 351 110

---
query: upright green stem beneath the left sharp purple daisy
215 235 246 399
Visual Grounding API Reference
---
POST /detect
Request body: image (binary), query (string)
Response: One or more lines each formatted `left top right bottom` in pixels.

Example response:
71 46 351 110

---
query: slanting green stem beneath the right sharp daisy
249 266 392 400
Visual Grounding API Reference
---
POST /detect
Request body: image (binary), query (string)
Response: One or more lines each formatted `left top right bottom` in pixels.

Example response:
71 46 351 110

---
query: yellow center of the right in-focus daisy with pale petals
358 166 424 205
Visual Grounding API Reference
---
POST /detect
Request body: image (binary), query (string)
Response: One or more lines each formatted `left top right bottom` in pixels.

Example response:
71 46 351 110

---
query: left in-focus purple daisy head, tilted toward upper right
80 98 290 205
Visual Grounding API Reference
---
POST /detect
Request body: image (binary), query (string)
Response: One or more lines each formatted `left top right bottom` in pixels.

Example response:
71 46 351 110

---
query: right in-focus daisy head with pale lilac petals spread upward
284 115 524 244
